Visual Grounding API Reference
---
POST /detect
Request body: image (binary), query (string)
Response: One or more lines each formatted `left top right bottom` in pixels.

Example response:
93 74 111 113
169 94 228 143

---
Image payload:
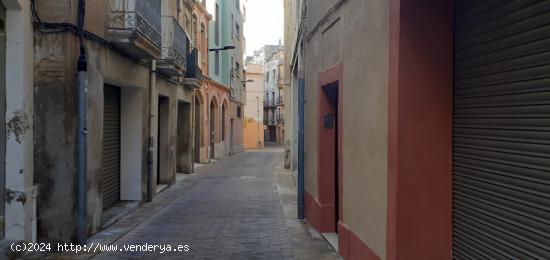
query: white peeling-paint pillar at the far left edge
0 1 38 250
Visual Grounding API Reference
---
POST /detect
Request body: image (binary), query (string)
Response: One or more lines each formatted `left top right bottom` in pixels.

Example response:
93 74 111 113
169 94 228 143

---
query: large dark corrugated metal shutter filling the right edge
453 0 550 259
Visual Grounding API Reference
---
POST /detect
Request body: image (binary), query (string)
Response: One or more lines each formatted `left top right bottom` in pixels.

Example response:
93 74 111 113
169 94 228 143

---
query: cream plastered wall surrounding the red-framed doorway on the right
305 0 389 259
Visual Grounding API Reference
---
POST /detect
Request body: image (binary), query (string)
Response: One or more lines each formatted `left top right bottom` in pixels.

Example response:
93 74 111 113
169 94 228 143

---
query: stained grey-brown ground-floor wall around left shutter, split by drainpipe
34 30 149 241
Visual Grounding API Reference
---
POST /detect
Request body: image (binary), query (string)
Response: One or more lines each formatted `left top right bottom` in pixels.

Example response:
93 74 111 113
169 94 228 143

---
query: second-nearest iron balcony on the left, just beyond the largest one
157 16 189 76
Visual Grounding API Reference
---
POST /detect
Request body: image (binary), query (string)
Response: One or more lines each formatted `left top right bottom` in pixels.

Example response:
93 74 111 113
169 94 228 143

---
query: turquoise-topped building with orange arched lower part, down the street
205 0 246 158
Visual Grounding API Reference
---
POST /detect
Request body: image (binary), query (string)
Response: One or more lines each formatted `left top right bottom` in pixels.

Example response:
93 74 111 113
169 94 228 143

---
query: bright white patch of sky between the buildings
244 0 284 56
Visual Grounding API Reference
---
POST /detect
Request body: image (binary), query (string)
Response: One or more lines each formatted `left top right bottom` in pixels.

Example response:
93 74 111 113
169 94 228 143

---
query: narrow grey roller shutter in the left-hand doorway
101 86 120 208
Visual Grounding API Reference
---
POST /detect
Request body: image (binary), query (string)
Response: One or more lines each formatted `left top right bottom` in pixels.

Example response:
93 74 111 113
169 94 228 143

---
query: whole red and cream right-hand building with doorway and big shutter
285 0 550 259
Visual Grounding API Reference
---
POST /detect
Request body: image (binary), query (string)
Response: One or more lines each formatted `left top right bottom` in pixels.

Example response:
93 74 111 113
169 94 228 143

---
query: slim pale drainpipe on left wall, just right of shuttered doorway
147 60 157 202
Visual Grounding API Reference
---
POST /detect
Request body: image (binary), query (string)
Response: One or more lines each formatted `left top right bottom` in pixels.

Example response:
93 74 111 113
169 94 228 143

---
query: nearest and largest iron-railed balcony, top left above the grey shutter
108 0 162 59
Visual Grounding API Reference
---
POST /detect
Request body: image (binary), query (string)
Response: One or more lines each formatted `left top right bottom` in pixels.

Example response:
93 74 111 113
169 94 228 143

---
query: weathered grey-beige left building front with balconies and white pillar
8 0 201 246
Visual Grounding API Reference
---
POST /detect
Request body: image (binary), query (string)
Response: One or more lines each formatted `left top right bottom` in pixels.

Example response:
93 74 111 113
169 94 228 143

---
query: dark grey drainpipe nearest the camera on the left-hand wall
76 0 88 245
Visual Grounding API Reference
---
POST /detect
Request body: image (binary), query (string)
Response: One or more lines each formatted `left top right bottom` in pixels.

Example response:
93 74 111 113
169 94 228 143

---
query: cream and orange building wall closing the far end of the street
243 63 265 149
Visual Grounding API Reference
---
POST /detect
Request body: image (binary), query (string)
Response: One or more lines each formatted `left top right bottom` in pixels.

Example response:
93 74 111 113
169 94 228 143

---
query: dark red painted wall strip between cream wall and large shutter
387 0 453 260
